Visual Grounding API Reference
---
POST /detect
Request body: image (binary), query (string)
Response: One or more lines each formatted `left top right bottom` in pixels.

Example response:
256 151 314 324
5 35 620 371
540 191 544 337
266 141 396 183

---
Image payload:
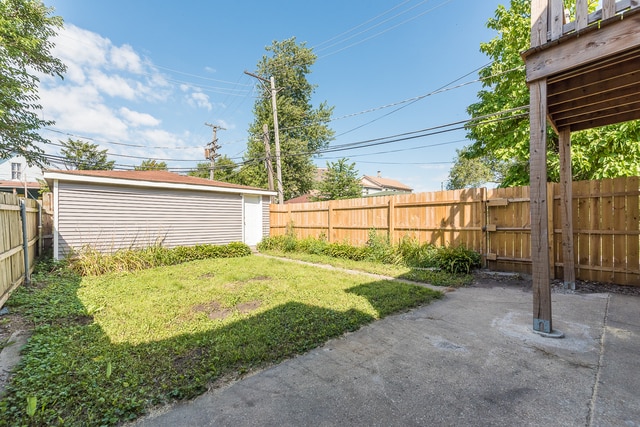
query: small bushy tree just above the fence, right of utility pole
312 158 362 201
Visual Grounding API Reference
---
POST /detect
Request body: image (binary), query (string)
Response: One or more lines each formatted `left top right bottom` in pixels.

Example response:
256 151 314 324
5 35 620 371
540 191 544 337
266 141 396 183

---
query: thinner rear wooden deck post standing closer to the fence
558 128 576 289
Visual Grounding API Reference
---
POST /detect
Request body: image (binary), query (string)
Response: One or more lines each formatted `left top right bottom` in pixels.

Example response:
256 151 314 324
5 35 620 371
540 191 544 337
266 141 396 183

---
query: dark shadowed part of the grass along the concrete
0 277 441 425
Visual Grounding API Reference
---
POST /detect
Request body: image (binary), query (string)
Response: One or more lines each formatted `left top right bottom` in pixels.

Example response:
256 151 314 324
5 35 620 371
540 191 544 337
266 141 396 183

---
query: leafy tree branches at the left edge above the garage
0 0 66 165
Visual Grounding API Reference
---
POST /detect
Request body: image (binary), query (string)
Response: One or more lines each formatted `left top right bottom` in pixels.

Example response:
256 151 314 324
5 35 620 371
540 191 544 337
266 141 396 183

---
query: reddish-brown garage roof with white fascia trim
44 170 276 195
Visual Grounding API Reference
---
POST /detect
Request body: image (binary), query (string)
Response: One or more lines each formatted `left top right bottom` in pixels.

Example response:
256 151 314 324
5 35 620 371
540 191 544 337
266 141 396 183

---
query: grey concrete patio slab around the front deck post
135 287 640 426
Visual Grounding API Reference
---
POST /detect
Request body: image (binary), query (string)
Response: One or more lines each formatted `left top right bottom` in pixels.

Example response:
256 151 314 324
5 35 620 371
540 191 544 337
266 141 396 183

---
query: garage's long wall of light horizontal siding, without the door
56 182 242 255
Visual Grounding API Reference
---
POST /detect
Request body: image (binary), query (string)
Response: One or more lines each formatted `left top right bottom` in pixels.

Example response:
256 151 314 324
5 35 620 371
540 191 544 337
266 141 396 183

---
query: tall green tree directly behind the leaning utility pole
242 37 333 199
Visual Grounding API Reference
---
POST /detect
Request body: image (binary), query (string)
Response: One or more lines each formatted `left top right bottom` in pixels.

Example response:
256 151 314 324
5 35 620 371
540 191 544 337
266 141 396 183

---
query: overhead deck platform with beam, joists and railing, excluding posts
523 0 640 132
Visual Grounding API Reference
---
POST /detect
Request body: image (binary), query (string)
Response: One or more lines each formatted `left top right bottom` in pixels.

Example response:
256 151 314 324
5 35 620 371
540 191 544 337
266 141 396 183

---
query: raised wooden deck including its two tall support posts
522 0 640 334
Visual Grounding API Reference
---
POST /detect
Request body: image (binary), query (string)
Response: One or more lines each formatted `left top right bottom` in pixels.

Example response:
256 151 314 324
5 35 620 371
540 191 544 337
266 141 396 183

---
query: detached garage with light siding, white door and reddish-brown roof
44 170 275 259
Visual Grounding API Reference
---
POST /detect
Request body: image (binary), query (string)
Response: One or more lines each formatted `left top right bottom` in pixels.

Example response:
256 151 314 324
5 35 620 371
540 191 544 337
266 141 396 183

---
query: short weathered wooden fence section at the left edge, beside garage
0 193 43 307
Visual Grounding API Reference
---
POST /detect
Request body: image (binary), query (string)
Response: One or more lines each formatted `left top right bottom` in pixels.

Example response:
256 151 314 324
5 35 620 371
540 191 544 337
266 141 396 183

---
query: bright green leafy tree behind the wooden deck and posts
462 0 640 187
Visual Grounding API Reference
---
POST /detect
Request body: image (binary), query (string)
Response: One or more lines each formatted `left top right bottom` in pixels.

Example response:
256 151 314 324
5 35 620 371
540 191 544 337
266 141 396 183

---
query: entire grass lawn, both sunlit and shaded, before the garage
0 256 442 425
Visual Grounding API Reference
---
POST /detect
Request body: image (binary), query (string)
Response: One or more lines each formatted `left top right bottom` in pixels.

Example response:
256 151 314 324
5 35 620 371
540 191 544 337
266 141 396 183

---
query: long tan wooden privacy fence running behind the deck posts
270 177 640 286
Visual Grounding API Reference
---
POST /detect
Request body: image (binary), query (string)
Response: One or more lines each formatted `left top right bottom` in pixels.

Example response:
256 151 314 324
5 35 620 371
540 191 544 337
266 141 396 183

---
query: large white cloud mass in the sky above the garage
39 24 213 166
